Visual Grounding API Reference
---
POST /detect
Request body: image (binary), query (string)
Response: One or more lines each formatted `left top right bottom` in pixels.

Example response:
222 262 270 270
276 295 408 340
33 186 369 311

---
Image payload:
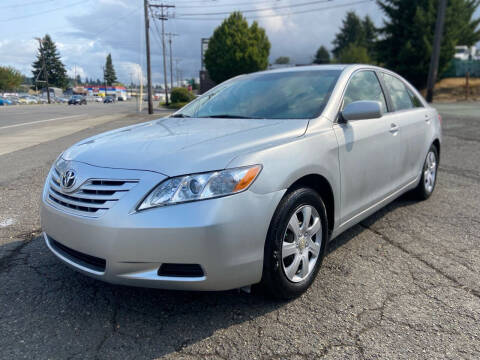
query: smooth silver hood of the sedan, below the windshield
62 118 308 176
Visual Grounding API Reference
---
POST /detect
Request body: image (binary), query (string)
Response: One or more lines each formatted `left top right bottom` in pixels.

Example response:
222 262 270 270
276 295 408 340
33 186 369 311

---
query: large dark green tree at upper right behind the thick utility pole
377 0 480 88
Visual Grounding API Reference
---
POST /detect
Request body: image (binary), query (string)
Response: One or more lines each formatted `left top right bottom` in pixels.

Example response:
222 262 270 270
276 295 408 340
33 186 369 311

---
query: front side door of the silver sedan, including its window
333 70 392 223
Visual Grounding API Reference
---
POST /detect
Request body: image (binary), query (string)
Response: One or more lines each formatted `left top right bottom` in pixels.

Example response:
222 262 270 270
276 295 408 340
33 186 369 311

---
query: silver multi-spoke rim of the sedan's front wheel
282 205 322 282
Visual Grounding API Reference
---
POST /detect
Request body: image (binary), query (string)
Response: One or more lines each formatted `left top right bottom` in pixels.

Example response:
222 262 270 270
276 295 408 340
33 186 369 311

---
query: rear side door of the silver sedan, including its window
381 72 431 189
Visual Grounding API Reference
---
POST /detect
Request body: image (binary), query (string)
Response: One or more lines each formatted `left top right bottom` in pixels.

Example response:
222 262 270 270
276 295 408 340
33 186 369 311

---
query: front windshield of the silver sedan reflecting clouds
173 70 341 119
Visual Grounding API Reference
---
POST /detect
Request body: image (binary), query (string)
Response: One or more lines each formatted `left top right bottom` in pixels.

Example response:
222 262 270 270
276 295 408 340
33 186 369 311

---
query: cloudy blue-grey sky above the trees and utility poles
0 0 480 83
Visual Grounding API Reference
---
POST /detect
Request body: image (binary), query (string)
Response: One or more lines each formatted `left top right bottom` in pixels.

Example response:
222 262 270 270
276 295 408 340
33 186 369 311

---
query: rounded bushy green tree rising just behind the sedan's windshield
205 12 270 84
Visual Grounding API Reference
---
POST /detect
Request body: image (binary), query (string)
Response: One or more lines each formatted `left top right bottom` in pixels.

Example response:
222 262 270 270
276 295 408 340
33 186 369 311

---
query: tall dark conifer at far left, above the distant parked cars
32 34 68 89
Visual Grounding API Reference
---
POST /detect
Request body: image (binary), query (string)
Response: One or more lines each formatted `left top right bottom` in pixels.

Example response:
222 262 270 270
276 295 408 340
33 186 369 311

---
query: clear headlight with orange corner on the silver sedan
137 165 262 210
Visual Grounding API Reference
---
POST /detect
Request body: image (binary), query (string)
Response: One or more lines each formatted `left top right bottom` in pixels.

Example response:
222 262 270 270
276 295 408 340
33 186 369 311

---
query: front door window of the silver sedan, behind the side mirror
343 71 387 113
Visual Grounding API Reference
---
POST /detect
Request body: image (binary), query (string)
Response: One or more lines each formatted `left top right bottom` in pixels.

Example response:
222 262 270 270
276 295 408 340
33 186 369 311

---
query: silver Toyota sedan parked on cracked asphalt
41 65 441 298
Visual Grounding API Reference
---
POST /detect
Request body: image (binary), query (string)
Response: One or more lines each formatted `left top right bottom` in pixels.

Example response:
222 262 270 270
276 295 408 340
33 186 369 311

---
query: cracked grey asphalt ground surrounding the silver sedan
0 103 480 359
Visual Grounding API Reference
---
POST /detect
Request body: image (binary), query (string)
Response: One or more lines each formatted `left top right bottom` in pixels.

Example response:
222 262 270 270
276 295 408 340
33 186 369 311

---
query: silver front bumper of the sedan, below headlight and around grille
41 164 284 290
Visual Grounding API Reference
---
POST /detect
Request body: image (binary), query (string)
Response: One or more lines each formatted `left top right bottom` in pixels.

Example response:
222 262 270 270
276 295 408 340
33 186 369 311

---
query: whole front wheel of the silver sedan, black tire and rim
261 188 328 300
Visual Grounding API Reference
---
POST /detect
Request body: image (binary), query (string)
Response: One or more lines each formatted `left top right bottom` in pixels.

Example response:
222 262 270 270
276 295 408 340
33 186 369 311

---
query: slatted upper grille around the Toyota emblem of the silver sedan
48 169 138 217
